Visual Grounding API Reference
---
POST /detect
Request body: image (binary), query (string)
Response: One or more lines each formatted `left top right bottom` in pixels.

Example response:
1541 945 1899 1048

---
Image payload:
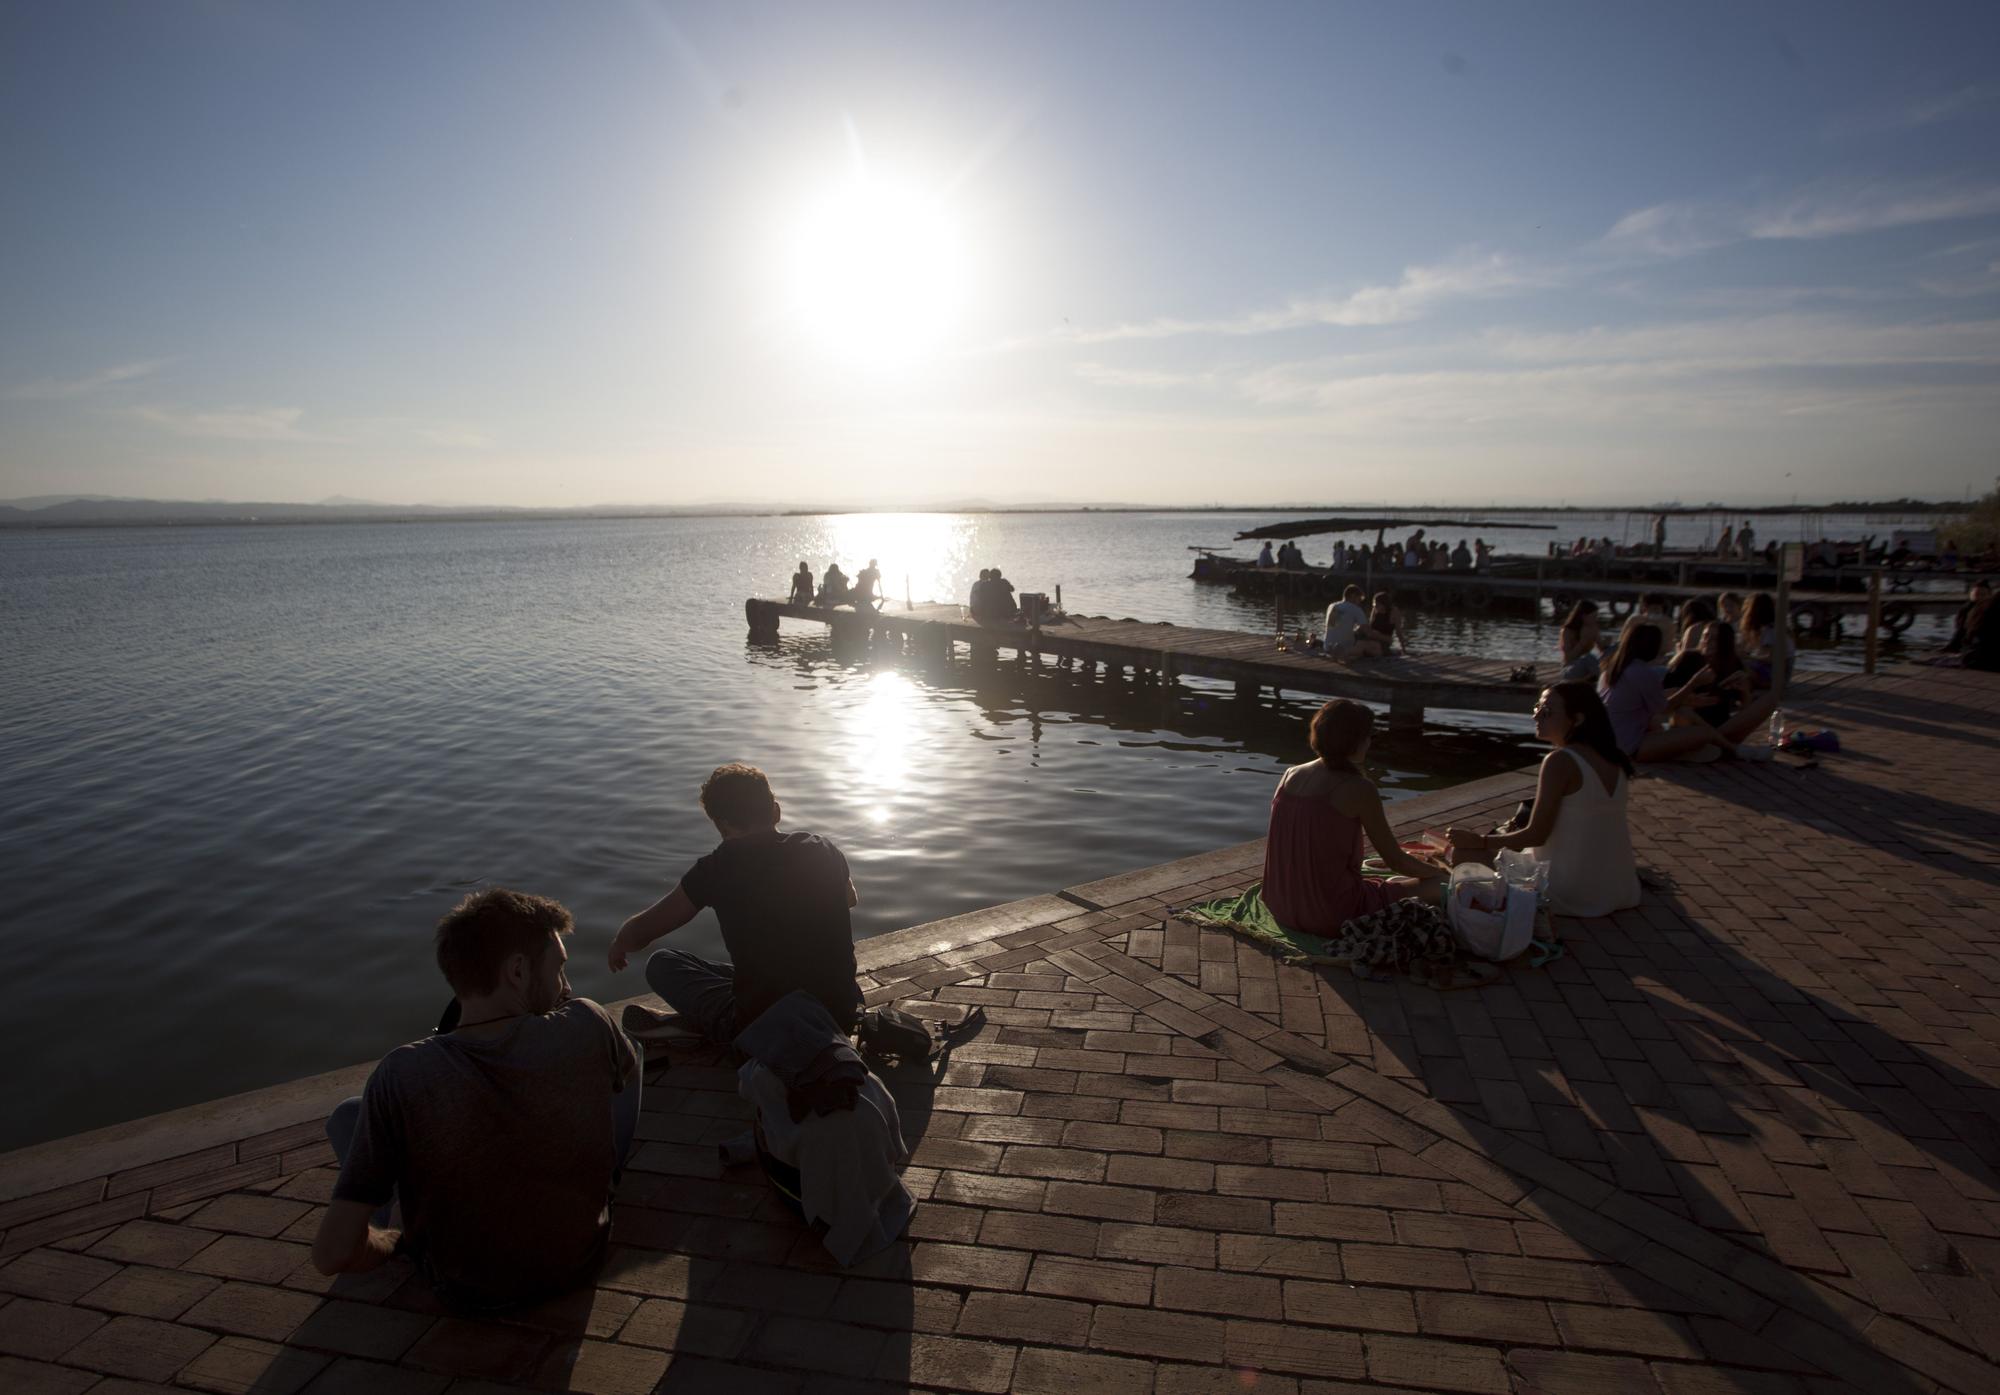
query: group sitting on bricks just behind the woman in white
1560 592 1792 761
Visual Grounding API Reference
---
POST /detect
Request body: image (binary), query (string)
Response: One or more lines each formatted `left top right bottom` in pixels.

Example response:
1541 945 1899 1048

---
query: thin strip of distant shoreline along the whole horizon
0 498 1984 530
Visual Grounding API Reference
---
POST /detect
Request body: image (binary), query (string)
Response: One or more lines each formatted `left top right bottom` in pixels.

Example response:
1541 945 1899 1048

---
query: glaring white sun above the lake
790 168 964 370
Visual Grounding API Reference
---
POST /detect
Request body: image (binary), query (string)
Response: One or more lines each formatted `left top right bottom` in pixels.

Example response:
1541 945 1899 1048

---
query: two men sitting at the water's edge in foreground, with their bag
312 765 892 1313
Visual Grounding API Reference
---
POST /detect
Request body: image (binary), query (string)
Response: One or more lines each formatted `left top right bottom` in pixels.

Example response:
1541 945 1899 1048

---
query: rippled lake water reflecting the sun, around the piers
0 514 1936 1147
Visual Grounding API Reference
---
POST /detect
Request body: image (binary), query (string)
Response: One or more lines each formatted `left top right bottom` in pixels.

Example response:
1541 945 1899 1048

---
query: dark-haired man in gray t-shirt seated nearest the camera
312 889 640 1309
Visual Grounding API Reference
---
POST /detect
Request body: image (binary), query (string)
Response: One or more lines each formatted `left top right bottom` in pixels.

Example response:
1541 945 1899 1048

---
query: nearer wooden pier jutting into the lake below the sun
744 598 1554 729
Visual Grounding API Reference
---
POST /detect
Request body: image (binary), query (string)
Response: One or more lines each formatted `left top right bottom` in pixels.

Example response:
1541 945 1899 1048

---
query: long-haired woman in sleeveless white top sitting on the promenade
1446 684 1638 915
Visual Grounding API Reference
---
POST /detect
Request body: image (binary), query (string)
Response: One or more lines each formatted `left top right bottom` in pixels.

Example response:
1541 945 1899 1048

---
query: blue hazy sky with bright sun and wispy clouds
0 0 2000 508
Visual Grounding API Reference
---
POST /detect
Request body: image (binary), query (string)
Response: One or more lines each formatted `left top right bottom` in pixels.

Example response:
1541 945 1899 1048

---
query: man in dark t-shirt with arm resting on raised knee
610 765 862 1043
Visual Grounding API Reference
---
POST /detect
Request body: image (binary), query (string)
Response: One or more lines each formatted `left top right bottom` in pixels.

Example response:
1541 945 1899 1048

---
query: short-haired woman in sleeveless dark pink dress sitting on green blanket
1264 698 1450 939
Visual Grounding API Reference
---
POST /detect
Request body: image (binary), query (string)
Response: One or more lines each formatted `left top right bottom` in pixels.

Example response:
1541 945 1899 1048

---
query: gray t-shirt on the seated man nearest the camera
334 997 638 1307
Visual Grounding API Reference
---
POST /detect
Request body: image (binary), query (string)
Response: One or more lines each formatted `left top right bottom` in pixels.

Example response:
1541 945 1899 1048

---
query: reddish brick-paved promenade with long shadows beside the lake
0 670 2000 1395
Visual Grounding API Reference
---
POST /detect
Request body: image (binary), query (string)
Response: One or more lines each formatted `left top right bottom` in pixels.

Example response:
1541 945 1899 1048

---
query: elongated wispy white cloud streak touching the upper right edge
1602 180 2000 256
